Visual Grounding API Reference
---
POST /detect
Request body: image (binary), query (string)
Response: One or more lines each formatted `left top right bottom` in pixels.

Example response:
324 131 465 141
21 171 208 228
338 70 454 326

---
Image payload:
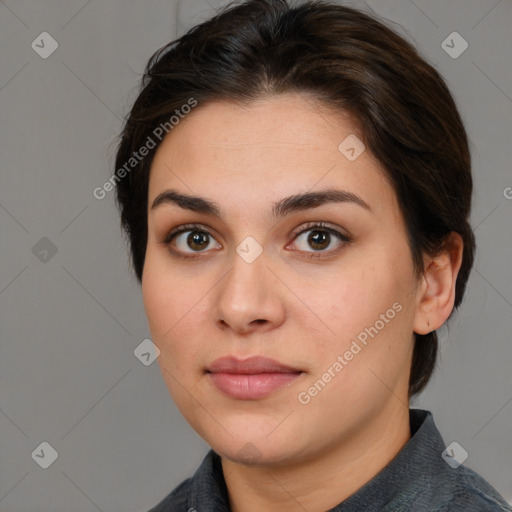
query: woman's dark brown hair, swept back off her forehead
115 0 475 396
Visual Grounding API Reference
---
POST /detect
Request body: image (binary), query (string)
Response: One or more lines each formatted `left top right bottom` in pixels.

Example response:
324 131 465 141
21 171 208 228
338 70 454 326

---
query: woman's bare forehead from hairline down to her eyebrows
149 94 397 223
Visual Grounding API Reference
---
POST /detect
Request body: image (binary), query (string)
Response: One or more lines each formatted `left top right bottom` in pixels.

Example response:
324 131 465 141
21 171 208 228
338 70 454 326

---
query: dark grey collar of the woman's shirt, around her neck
187 409 446 512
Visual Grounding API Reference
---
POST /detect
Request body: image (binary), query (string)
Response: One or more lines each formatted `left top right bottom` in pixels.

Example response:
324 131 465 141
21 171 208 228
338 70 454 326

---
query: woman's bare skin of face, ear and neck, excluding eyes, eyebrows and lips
142 94 462 512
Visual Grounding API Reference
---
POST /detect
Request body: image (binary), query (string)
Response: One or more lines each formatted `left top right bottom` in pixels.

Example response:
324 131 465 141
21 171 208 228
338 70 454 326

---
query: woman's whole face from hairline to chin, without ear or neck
142 94 417 464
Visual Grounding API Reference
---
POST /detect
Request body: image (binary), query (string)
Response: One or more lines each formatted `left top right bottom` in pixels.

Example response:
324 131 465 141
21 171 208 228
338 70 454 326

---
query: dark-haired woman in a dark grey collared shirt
116 0 510 512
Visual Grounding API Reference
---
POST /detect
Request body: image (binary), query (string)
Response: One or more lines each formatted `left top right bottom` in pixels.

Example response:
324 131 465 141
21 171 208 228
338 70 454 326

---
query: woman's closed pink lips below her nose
206 356 304 400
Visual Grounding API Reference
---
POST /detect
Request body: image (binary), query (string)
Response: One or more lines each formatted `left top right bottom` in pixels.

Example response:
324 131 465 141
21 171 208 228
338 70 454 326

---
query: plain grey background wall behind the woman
0 0 512 512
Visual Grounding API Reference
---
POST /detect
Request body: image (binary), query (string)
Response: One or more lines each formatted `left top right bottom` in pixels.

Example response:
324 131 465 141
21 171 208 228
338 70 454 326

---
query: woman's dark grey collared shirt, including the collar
149 409 512 512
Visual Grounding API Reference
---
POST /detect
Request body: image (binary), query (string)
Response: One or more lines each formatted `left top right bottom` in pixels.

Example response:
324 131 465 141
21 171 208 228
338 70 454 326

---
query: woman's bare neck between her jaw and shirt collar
222 400 411 512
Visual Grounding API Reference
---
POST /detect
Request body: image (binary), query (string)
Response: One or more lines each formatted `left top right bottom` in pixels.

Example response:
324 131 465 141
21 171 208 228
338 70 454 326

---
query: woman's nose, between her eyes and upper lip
214 247 286 334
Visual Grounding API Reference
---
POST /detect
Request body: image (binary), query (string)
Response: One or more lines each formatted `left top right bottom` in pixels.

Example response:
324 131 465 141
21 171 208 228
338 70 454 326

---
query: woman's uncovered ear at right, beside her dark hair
413 231 464 334
